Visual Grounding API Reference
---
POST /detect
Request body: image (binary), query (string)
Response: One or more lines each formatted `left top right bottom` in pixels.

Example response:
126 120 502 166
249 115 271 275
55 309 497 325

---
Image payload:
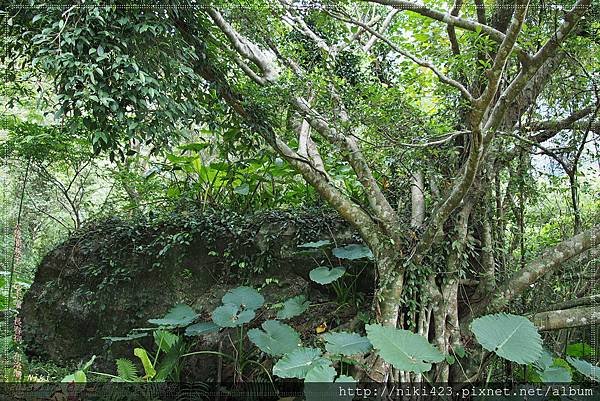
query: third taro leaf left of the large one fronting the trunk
248 320 300 356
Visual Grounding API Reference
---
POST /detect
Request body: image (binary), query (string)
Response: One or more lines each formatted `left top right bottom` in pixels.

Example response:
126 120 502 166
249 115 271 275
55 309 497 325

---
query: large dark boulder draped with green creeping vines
20 211 370 374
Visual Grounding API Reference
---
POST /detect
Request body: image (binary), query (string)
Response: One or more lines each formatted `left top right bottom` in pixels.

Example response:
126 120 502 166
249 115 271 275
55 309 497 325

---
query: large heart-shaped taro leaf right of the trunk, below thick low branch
471 313 542 364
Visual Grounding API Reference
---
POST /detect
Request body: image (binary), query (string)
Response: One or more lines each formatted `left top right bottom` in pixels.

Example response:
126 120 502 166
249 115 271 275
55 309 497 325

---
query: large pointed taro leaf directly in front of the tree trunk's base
366 324 444 373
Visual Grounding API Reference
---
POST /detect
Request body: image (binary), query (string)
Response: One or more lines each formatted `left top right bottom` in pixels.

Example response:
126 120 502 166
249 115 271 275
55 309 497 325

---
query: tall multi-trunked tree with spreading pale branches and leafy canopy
8 0 600 381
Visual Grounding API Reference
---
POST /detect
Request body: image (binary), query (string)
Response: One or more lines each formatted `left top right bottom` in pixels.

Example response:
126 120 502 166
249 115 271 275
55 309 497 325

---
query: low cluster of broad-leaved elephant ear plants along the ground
64 286 599 401
